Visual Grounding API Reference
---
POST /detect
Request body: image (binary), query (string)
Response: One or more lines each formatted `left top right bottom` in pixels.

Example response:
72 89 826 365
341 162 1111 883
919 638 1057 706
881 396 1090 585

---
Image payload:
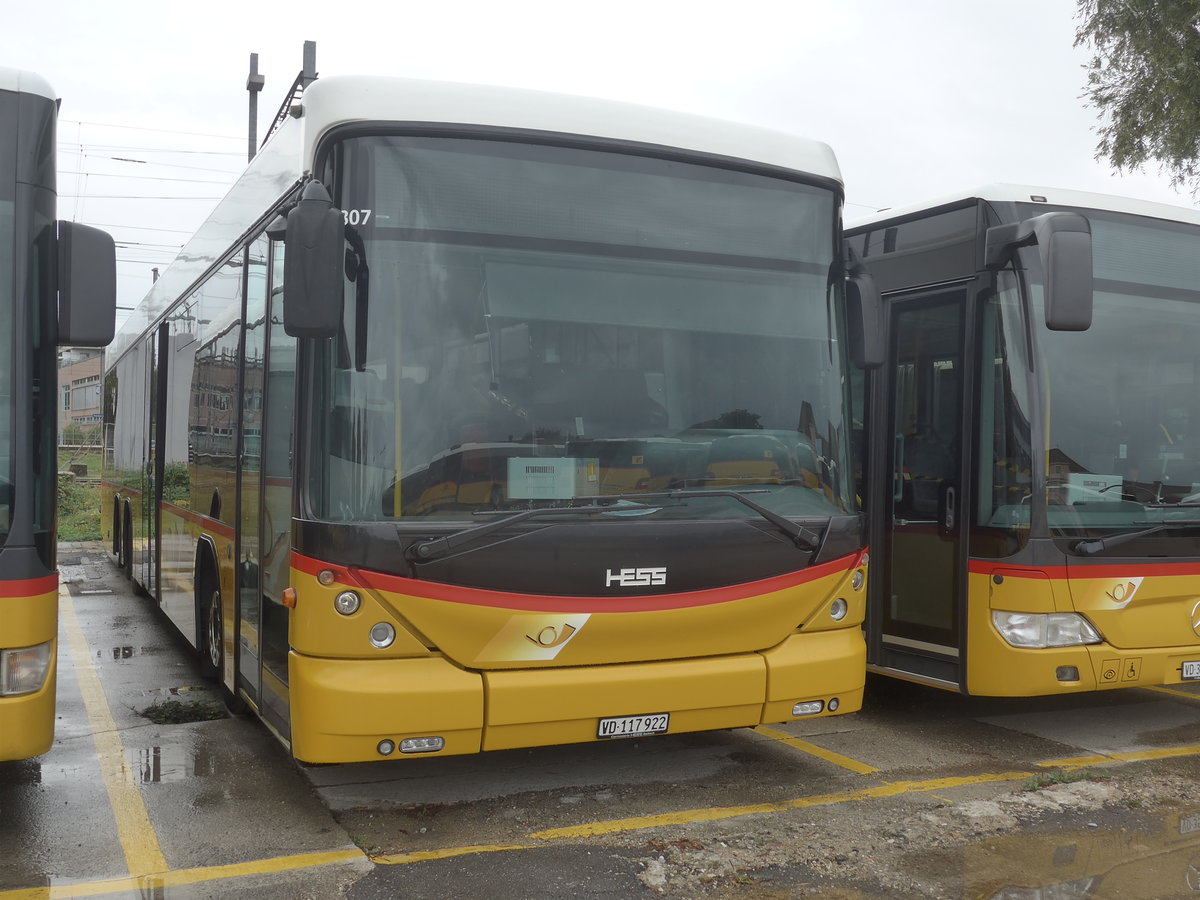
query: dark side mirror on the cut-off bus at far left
55 222 116 347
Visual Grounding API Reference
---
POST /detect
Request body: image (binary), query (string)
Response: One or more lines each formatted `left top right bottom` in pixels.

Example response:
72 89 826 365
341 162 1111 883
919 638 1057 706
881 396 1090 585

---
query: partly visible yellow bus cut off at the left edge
0 67 116 761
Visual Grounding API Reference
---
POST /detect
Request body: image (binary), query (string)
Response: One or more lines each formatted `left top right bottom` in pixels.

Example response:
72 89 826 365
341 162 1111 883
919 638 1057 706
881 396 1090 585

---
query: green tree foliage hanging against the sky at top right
1075 0 1200 192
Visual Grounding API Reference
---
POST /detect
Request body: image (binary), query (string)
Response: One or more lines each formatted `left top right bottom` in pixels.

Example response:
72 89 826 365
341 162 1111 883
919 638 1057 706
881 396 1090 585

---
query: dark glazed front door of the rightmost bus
869 288 966 686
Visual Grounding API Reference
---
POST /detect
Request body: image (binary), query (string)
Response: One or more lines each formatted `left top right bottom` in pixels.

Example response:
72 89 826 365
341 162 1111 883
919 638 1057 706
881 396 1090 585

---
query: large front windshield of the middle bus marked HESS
307 137 854 521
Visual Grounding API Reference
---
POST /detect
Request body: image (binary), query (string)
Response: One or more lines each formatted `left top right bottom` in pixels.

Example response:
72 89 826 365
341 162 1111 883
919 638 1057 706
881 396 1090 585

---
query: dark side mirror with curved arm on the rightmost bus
984 211 1092 331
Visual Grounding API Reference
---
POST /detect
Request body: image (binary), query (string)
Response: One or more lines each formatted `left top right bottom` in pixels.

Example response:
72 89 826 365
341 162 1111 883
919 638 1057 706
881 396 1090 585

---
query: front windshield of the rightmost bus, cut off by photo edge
1040 210 1200 536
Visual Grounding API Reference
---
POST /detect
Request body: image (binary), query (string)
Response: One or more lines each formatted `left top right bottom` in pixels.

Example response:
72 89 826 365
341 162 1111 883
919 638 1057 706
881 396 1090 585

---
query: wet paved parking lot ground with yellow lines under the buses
0 544 1200 900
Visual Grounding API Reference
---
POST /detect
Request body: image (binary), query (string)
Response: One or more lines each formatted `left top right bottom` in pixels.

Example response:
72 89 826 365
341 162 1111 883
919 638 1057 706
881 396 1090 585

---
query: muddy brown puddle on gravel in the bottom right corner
962 808 1200 900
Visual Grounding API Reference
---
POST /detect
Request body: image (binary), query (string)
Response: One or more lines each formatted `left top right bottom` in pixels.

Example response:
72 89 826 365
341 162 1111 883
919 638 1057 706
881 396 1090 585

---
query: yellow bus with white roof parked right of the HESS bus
847 185 1200 696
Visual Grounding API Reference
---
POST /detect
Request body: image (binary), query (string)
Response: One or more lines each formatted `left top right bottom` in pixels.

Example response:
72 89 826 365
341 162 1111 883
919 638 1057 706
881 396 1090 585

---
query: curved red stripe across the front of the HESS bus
292 553 863 612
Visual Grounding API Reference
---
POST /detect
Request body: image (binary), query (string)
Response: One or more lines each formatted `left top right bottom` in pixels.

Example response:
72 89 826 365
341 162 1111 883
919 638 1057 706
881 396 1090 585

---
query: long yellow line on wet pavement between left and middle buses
59 589 167 876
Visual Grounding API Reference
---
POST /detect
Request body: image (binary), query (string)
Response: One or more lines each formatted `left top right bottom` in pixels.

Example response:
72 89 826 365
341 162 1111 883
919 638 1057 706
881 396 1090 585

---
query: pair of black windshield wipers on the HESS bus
407 488 821 563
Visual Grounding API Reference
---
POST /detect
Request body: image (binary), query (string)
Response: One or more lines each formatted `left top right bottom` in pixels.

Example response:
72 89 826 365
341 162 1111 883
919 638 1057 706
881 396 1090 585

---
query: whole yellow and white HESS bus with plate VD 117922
103 77 878 762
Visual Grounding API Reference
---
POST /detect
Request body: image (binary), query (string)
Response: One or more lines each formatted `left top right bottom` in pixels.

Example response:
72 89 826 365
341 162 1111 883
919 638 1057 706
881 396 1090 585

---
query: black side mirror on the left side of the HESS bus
283 180 346 337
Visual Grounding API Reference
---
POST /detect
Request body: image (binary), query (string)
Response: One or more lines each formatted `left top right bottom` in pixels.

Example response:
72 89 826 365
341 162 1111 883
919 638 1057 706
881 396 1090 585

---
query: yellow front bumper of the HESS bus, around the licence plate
289 628 866 763
